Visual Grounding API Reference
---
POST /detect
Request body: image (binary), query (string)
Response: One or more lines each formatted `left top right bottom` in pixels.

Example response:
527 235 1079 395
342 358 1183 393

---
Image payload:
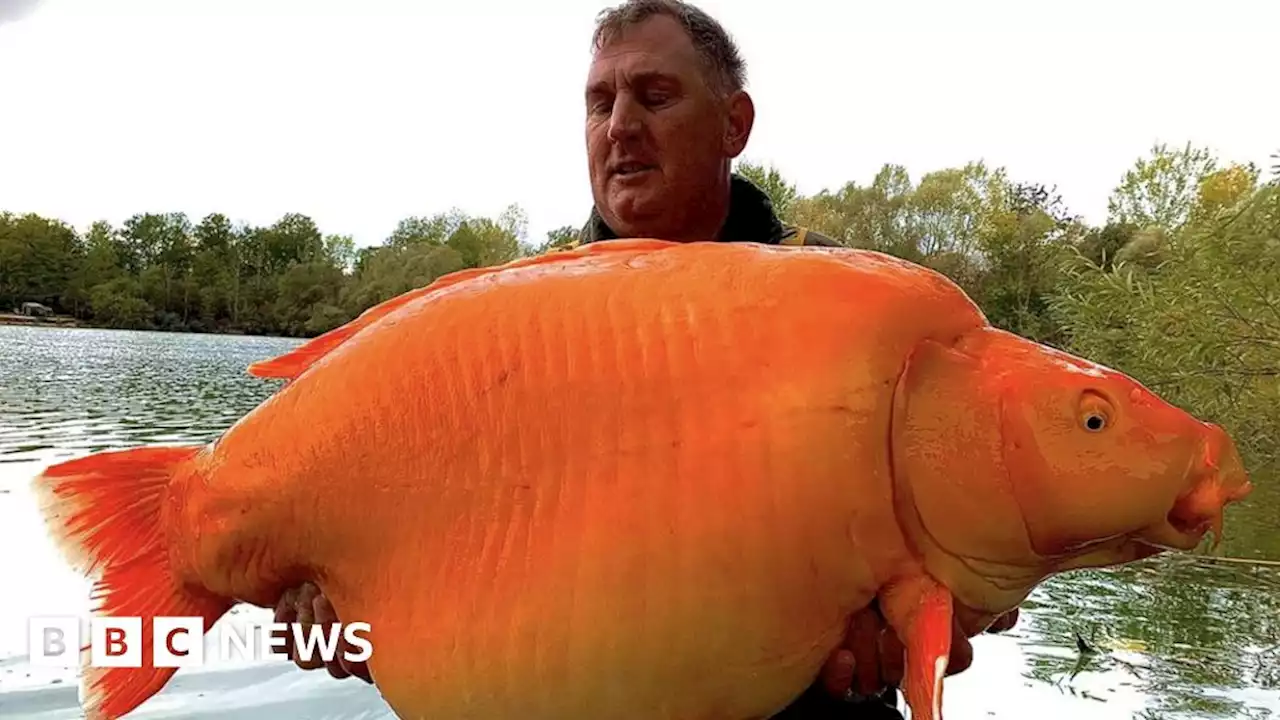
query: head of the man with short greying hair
585 0 755 241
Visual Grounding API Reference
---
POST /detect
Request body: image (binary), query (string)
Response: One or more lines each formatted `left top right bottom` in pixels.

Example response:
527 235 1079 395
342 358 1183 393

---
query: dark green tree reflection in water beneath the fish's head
1020 556 1280 720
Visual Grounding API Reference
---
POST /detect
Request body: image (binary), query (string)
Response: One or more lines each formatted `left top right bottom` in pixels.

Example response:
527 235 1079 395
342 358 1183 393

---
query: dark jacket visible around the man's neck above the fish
554 174 840 250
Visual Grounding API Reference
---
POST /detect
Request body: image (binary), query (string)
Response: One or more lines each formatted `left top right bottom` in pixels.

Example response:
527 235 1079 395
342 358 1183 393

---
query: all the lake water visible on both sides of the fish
0 327 1280 720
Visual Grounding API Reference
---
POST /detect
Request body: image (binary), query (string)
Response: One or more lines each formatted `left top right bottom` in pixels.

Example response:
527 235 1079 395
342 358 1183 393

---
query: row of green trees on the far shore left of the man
0 205 534 337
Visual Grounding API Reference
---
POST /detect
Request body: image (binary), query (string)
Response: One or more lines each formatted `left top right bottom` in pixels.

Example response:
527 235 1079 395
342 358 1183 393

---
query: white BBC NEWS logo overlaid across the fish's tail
28 616 374 669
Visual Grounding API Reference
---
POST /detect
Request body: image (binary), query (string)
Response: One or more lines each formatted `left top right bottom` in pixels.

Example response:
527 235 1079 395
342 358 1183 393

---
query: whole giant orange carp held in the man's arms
27 240 1249 720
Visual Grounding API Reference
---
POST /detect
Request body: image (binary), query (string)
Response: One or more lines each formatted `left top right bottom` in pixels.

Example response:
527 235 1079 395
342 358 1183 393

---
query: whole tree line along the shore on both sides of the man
0 145 1280 455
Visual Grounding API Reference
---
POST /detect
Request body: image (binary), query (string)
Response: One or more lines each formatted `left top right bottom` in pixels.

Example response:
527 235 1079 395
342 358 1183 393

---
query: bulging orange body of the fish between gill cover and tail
197 244 962 720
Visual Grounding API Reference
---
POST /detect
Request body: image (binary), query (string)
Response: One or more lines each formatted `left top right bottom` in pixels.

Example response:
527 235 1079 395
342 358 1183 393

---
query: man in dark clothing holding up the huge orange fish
276 0 1016 720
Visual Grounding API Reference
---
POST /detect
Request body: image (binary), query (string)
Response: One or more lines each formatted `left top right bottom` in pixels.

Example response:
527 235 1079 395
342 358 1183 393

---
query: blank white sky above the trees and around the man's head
0 0 1280 245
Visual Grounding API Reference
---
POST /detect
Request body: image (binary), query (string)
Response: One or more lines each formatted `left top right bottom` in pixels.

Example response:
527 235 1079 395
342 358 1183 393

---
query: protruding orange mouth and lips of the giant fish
1137 425 1253 551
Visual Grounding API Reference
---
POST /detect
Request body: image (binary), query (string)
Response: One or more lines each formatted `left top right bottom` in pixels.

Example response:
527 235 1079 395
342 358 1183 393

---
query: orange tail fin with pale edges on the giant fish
35 446 233 720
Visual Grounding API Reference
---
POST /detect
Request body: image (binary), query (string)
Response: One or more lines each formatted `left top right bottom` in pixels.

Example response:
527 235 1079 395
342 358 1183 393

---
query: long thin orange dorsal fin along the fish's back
241 238 678 380
